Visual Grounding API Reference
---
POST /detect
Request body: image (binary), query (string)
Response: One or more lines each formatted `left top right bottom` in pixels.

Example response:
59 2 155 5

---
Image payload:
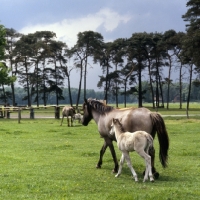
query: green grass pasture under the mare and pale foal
0 117 200 200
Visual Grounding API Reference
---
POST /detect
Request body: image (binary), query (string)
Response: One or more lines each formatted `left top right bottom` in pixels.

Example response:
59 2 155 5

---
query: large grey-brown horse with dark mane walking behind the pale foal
82 99 169 178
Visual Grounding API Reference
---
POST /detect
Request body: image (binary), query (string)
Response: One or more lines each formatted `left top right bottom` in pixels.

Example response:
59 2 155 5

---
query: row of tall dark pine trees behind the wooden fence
0 0 200 109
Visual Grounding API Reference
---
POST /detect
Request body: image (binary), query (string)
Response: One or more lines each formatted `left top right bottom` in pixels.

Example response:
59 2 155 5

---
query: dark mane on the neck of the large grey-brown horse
88 99 114 114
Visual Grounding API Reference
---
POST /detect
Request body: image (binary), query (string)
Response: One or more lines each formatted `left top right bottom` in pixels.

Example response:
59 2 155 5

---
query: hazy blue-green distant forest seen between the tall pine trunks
0 82 200 106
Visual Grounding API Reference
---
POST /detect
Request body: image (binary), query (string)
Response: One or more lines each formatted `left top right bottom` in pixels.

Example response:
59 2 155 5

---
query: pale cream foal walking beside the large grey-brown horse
110 118 154 182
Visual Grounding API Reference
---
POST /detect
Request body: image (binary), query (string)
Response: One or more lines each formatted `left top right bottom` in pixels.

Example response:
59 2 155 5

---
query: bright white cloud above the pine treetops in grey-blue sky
19 8 131 47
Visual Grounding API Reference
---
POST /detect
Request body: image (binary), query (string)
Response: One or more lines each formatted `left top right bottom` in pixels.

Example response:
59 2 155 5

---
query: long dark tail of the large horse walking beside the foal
151 112 169 168
